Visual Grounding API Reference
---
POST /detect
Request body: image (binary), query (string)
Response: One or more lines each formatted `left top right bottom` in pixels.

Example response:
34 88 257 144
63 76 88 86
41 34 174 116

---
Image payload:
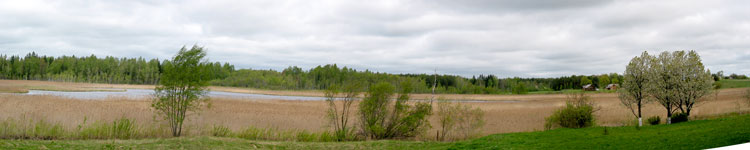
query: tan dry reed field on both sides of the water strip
0 80 750 135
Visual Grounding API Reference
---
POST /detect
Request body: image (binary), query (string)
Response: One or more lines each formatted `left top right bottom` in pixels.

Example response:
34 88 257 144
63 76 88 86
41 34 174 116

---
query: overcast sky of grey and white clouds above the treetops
0 0 750 77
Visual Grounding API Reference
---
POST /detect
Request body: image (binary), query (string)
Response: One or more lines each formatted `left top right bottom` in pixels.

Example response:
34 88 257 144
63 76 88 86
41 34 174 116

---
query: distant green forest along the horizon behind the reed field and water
0 52 636 94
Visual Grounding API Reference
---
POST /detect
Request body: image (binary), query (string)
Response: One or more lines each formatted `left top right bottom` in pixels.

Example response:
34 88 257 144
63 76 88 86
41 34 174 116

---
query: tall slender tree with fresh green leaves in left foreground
151 46 211 136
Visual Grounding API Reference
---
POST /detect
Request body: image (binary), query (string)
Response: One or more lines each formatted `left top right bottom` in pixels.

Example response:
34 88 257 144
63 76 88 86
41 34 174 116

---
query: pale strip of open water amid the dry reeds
26 89 520 103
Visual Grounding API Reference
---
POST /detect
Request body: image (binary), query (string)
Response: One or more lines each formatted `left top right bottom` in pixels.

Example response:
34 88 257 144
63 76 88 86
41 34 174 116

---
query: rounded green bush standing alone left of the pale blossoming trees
544 92 596 130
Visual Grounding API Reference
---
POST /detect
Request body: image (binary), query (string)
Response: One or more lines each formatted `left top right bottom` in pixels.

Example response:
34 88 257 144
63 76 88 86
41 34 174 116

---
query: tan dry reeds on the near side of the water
0 81 750 141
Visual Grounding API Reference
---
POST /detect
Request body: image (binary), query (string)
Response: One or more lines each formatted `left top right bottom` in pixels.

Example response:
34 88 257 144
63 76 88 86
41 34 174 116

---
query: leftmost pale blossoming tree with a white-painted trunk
617 51 652 126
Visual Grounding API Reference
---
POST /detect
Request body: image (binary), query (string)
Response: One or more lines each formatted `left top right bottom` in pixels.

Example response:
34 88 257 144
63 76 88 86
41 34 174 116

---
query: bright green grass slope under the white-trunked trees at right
451 115 750 149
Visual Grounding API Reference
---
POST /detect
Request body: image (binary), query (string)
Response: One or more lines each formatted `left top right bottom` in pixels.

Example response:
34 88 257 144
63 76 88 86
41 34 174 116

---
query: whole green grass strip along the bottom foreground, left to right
0 115 750 149
